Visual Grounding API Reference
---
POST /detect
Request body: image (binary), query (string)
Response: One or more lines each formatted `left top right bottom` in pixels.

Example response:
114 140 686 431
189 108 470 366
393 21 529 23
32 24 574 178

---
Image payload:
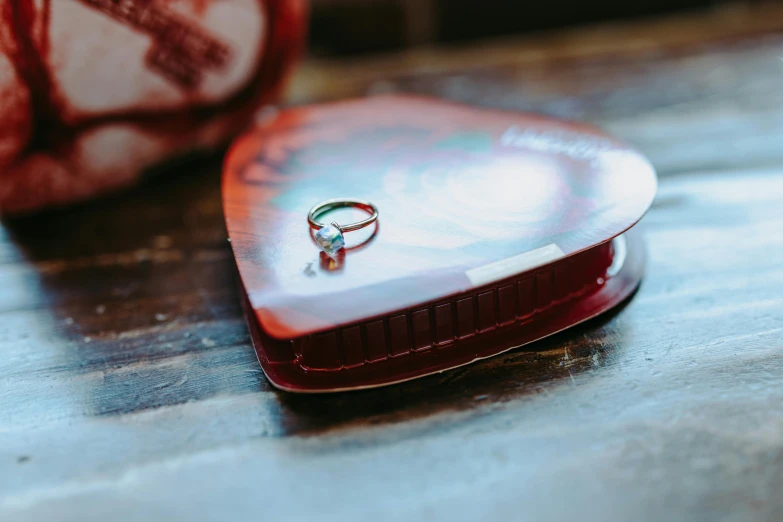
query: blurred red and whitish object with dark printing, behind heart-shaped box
0 0 305 213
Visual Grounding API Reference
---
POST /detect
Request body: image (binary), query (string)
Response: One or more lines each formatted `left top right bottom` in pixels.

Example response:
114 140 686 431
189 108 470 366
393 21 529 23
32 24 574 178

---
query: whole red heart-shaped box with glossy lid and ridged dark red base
223 96 656 392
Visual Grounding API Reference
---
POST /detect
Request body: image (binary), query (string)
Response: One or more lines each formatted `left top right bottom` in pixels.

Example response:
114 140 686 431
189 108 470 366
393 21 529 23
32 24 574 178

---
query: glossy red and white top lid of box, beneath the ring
223 96 656 339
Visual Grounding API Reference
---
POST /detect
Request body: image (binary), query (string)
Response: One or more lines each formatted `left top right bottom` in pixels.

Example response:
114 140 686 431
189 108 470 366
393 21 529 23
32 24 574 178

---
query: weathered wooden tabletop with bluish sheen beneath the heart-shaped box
0 5 783 522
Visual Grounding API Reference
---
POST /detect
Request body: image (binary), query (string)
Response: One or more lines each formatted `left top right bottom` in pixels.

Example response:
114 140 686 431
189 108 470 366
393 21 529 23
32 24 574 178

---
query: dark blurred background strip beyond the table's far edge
310 0 740 56
